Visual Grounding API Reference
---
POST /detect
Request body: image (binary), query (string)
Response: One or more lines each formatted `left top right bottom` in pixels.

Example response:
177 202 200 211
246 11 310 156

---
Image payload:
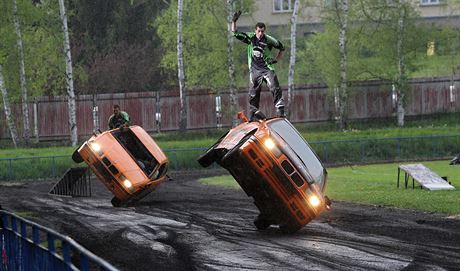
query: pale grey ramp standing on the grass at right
397 164 455 190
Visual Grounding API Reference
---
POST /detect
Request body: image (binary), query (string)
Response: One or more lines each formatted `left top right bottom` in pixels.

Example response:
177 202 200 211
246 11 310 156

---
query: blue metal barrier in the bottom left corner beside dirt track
0 210 117 271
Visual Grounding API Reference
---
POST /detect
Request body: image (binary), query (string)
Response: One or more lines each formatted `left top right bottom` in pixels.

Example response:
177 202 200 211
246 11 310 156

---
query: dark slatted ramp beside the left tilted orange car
48 167 91 197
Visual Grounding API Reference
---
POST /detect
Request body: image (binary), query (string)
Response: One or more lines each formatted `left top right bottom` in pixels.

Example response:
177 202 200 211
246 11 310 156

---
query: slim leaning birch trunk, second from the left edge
13 0 30 145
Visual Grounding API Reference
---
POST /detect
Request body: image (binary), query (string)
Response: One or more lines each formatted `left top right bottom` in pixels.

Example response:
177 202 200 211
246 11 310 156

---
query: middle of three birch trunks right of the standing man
339 0 348 130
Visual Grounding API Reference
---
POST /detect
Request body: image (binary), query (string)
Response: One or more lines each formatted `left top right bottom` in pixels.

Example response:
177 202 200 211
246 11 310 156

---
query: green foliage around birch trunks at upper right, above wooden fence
299 0 433 87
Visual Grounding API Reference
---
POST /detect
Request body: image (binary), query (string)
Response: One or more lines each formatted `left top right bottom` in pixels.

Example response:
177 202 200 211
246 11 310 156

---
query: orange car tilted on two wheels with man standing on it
198 113 331 233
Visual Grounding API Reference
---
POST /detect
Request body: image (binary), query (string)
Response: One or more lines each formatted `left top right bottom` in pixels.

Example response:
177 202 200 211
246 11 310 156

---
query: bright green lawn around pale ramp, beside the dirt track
200 161 460 215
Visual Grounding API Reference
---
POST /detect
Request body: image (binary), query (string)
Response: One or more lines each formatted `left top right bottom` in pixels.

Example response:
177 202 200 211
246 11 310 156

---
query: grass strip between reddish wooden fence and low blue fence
0 113 460 158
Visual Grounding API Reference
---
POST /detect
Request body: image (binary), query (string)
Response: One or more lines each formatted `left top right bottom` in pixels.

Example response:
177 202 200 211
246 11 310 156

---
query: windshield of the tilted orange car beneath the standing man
268 119 325 188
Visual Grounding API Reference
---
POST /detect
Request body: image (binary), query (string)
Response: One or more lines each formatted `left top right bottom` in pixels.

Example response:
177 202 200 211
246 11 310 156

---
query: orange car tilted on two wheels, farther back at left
72 126 168 206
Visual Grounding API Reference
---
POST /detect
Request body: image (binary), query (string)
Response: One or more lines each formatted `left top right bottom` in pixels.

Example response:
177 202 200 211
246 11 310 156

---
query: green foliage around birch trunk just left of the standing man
155 0 253 90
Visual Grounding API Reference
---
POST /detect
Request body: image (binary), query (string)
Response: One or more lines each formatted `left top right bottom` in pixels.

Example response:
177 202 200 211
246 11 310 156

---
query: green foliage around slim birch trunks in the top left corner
0 0 70 99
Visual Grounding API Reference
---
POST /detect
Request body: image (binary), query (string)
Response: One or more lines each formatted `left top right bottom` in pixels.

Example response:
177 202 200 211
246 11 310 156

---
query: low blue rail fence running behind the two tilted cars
0 135 460 181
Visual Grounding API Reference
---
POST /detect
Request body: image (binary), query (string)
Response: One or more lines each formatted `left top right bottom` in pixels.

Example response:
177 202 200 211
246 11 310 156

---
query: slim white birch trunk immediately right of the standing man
287 0 299 118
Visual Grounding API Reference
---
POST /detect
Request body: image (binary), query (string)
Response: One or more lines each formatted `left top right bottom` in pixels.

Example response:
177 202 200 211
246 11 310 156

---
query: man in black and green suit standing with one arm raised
232 11 285 120
